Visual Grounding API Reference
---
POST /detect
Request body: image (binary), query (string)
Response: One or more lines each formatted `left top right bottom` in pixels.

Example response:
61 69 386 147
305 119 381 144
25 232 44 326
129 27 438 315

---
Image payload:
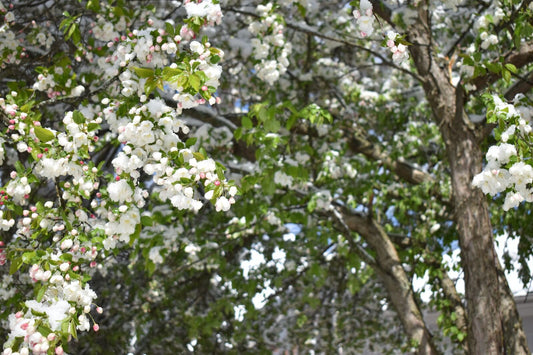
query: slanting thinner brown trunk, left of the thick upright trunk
344 214 438 355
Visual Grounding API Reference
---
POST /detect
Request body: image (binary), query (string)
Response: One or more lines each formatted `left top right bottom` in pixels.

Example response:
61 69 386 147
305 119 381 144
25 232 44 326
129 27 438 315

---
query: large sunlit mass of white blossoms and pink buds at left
0 0 237 355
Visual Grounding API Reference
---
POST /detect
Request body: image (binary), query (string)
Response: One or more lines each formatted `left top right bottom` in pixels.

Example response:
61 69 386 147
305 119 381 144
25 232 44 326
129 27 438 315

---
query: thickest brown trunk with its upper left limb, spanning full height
408 5 512 354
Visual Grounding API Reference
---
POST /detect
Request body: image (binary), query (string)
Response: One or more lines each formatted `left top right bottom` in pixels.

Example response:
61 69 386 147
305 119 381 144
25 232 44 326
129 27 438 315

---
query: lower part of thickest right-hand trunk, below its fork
441 121 503 354
